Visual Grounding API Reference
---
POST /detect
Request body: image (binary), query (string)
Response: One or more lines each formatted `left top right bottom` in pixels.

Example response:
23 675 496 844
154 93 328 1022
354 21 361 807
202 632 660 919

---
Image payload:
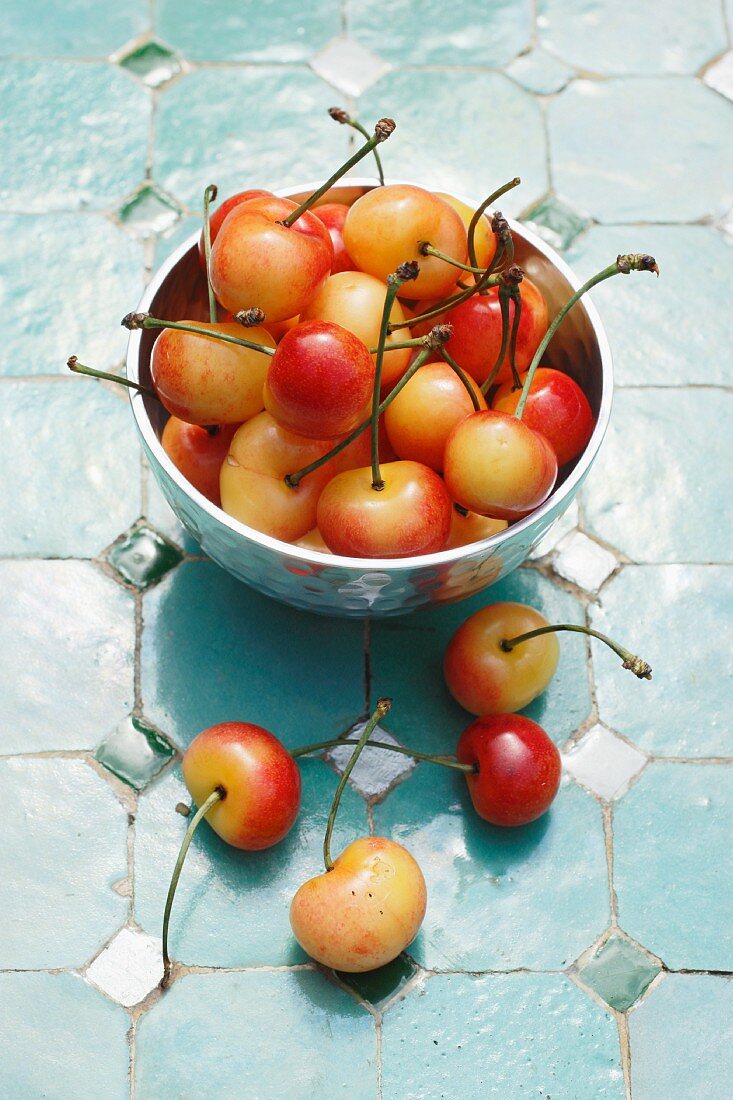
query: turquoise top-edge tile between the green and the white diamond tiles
155 0 341 63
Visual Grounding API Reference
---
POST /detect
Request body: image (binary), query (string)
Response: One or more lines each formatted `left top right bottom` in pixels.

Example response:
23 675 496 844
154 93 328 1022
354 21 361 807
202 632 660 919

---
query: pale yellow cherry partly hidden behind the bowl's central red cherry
302 271 412 388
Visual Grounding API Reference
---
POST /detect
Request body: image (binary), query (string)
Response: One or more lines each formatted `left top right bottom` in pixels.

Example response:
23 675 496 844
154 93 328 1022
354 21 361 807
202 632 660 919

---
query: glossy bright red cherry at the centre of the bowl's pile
264 321 374 439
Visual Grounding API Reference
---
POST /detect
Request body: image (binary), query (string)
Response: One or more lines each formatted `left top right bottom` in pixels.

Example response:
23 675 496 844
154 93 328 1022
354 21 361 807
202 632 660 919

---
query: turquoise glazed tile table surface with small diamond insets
0 0 733 1100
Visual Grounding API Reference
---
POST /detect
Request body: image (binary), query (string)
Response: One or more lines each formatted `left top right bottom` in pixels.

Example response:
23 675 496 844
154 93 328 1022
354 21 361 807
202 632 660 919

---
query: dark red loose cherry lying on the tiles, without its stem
456 714 561 825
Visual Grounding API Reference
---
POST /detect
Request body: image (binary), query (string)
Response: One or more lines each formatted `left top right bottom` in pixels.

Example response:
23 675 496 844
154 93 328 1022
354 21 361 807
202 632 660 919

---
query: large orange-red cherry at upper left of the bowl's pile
209 196 333 321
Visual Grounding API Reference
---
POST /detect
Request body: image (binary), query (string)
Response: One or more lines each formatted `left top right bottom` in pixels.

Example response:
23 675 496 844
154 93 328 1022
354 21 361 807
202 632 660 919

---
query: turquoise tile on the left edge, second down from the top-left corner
0 61 151 212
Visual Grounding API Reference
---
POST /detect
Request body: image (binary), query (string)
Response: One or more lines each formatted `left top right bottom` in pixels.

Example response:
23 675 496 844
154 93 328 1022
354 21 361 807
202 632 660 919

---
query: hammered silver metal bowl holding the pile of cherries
128 177 613 618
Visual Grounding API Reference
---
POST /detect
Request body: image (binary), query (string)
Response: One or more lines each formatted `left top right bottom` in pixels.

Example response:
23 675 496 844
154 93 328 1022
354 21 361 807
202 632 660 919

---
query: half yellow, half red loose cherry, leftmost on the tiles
182 722 300 851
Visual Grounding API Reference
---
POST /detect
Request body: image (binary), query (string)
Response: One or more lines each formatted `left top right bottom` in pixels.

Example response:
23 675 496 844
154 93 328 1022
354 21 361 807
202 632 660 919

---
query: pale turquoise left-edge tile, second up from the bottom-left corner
0 759 128 969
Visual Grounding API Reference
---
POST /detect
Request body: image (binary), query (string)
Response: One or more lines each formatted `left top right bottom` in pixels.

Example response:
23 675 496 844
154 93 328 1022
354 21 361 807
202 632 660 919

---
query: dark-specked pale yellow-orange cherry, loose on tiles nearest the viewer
291 836 427 974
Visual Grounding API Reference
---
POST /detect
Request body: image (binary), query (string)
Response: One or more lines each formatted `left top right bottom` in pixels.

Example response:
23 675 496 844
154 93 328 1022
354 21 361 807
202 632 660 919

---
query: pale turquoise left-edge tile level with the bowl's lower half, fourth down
0 378 141 558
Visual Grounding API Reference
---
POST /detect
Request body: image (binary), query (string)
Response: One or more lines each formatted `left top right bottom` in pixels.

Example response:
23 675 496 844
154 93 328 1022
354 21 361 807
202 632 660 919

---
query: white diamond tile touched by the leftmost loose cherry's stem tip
86 928 163 1009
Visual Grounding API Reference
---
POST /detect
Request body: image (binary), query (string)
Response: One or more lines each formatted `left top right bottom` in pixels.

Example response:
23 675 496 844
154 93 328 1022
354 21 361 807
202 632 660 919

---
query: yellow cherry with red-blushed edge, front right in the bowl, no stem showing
444 409 557 520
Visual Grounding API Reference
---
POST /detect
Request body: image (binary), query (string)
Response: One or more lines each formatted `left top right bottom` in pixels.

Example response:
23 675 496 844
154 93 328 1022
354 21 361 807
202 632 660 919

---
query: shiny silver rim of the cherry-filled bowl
127 176 613 573
